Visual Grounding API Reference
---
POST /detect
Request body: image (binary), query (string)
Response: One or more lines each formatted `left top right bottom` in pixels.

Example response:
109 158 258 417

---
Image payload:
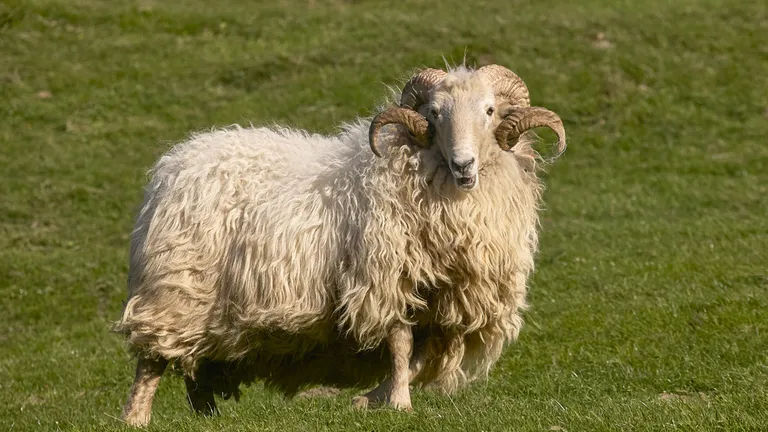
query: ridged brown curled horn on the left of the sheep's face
368 69 445 157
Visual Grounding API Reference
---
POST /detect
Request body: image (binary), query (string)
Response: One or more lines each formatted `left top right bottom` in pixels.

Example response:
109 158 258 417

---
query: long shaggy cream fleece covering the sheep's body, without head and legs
116 79 542 391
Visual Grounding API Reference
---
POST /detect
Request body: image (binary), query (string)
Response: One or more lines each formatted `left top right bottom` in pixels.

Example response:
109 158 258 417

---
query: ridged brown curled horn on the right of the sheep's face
477 65 566 157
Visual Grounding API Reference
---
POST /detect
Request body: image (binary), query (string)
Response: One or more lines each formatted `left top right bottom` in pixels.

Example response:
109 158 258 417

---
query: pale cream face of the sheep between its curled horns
420 71 499 191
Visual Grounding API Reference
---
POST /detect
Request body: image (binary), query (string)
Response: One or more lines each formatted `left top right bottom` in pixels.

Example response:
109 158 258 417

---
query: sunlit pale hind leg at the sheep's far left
123 357 168 426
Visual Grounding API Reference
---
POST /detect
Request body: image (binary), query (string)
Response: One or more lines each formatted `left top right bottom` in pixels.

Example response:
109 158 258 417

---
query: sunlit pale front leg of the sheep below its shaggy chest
352 323 425 411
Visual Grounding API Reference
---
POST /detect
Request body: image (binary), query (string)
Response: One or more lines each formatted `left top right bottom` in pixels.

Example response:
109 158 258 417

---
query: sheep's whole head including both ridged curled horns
369 65 565 190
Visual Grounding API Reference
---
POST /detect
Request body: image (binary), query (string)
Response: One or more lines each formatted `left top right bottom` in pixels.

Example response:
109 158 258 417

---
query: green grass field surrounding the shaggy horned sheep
0 0 768 431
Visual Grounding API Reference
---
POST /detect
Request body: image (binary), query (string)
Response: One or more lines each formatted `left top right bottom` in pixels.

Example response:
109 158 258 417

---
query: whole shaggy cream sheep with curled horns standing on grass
115 65 565 425
